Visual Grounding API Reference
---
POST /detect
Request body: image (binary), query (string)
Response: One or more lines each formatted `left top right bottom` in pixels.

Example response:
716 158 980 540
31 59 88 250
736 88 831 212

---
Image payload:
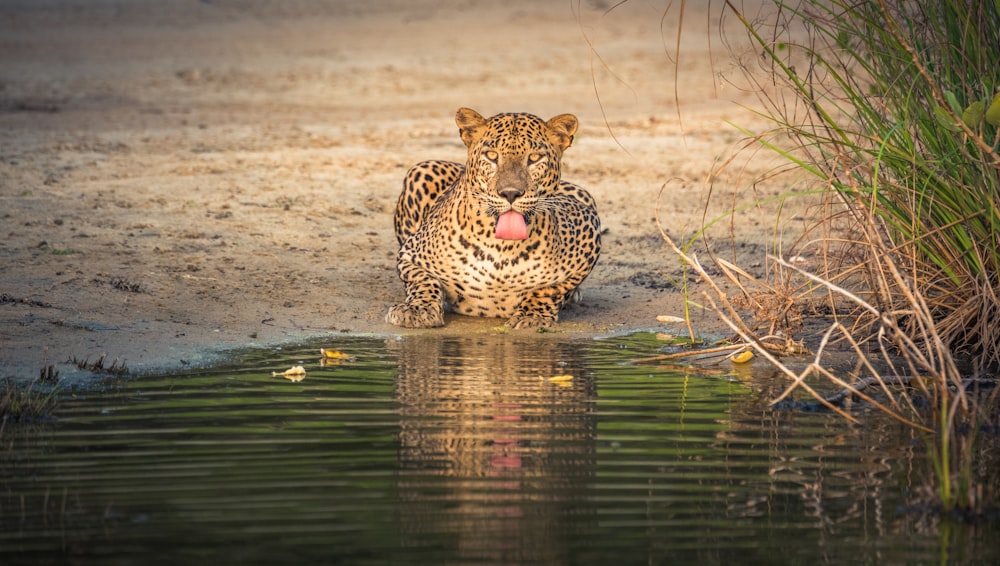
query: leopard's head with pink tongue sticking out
455 108 578 239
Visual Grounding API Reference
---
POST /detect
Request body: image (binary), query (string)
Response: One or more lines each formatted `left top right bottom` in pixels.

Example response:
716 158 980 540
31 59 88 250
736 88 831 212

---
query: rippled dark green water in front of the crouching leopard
0 335 1000 564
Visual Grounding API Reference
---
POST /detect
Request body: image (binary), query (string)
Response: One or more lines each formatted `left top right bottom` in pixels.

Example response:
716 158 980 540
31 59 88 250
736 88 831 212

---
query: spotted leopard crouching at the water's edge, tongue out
385 108 601 330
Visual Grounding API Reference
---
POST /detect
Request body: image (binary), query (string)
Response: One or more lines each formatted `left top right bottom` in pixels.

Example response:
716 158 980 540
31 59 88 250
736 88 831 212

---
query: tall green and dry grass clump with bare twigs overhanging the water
682 0 1000 511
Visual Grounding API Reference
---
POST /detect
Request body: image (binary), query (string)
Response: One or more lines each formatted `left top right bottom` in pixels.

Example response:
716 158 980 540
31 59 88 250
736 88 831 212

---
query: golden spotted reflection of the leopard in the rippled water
395 335 596 563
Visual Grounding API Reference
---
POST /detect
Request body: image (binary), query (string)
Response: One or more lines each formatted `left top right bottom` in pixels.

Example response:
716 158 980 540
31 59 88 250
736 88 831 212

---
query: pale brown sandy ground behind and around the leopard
0 0 801 382
